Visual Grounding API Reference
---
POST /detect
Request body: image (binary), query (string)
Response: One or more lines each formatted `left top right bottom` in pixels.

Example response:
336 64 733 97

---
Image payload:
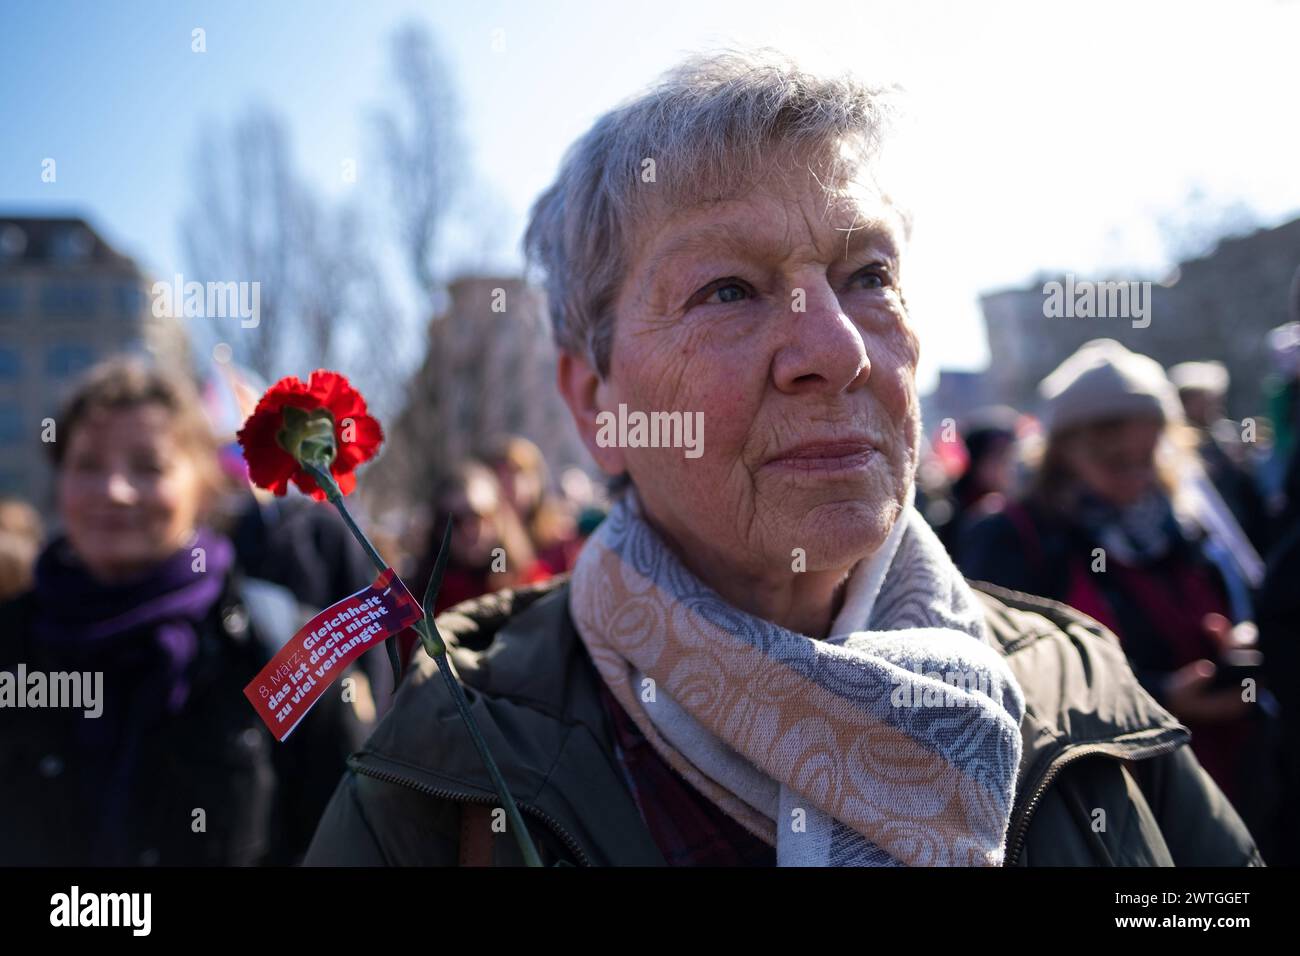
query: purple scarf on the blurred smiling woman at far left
31 529 234 864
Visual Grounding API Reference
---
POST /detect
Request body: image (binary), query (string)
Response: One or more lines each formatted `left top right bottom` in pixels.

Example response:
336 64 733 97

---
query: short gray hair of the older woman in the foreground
524 49 910 376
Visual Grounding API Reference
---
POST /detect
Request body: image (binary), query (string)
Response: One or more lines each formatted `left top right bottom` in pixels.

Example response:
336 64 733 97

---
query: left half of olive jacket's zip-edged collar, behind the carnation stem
348 579 664 866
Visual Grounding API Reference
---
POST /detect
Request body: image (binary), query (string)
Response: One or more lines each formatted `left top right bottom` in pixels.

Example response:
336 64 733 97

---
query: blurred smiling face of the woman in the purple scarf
59 405 203 580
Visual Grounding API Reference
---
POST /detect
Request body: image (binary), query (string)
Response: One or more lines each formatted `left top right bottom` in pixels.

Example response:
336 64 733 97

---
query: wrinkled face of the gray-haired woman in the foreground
597 158 918 575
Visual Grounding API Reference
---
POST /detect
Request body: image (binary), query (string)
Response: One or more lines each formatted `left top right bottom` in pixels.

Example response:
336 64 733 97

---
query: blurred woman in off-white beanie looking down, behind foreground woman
958 339 1269 853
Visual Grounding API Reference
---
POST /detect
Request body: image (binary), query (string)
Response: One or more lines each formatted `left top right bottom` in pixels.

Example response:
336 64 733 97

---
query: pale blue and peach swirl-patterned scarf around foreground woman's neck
571 490 1024 866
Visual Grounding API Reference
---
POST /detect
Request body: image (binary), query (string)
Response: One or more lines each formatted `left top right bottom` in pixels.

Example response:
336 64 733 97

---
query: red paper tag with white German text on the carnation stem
244 568 424 741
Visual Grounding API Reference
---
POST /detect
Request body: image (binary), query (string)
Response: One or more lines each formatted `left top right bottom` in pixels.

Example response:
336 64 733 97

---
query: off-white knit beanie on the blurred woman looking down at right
1039 338 1183 432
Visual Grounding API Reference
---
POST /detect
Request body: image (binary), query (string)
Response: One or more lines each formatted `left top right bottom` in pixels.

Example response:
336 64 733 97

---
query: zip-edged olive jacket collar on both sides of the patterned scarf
350 578 1191 865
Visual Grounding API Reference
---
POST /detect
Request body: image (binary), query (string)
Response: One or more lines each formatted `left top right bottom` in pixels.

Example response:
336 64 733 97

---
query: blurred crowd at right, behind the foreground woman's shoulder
920 330 1300 864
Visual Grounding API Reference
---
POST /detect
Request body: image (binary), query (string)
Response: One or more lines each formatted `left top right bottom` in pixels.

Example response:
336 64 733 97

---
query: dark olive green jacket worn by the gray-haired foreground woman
306 581 1262 866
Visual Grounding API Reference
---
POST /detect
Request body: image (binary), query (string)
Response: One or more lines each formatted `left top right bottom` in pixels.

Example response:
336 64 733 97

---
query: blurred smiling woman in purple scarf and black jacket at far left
0 359 367 865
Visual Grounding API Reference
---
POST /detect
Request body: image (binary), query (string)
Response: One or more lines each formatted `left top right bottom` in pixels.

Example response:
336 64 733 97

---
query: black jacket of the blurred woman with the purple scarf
0 575 367 866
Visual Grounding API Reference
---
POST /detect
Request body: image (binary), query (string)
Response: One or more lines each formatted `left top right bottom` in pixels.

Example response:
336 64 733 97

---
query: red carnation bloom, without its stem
239 368 384 501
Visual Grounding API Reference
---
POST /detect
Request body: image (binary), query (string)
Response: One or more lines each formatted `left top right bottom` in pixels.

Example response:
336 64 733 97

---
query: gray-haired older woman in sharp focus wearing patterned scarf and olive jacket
308 55 1258 866
